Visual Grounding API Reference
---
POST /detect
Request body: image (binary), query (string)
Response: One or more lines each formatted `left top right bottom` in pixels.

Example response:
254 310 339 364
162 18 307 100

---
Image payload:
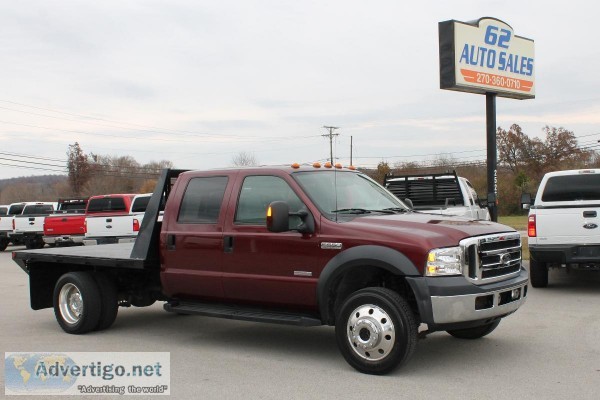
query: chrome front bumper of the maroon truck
407 268 529 330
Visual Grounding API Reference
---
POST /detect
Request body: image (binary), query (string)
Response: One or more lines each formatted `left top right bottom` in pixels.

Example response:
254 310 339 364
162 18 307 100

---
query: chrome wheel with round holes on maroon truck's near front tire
346 304 396 361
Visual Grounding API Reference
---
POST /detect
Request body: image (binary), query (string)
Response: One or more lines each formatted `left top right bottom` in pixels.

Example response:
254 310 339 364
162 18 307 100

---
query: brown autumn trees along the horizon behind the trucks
0 124 600 215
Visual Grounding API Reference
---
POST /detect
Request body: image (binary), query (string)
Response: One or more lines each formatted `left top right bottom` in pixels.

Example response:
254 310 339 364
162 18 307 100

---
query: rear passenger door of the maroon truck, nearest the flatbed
161 176 229 299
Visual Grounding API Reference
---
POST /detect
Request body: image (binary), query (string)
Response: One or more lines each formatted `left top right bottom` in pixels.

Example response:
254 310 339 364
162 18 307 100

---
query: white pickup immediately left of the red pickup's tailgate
11 202 56 249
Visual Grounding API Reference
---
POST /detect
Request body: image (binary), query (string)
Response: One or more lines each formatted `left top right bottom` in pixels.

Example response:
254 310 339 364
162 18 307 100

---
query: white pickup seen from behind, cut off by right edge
521 169 600 287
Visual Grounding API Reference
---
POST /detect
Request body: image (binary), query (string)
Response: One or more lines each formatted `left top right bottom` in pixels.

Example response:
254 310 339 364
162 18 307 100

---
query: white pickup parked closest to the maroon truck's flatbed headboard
83 193 152 245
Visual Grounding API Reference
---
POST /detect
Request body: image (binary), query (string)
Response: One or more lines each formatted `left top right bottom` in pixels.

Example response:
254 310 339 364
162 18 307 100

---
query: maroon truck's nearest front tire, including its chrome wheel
335 287 417 375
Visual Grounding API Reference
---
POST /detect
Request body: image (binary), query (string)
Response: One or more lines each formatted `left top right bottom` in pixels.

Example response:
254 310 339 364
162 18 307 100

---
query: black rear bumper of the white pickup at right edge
529 244 600 264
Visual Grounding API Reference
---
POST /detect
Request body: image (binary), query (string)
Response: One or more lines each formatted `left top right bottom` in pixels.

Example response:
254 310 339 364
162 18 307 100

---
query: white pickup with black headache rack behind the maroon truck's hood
384 171 490 221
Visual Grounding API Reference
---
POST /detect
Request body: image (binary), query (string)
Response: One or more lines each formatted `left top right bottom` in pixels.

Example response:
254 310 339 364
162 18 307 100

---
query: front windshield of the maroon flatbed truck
293 171 408 219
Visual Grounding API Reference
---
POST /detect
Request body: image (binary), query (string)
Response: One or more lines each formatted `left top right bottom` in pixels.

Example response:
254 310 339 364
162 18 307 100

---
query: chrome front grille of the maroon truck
461 233 521 284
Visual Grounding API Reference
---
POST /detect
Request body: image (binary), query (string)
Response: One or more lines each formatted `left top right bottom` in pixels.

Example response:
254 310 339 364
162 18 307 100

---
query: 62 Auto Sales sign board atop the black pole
439 17 535 99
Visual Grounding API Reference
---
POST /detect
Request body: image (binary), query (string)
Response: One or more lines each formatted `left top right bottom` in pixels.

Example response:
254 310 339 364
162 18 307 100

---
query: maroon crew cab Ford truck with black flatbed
13 164 528 374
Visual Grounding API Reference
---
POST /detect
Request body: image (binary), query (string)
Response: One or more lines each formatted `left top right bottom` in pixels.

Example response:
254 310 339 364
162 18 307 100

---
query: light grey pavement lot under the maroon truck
0 247 600 399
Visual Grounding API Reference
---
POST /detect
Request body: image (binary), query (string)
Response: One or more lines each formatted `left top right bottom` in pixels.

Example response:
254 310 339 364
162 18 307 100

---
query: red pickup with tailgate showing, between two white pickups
43 198 88 246
